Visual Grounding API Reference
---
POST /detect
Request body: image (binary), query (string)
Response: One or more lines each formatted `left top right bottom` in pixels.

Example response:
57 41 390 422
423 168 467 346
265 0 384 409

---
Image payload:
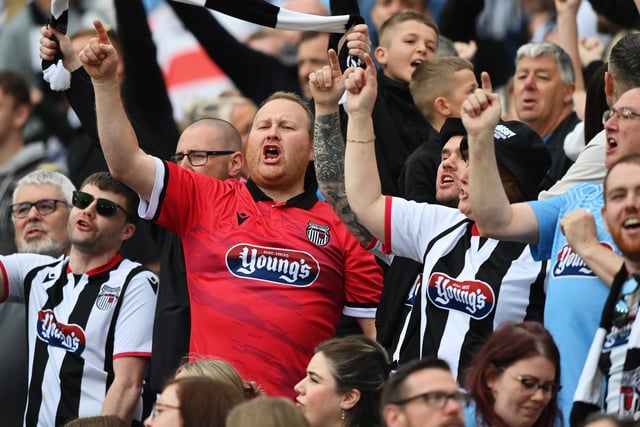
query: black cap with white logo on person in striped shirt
460 120 551 200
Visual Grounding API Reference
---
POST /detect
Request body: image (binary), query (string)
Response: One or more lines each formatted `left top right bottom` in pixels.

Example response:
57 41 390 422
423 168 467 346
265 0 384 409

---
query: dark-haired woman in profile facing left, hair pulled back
294 335 389 427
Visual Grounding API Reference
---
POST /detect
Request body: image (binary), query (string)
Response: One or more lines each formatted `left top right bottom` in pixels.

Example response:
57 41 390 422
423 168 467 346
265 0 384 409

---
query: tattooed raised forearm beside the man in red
313 112 373 245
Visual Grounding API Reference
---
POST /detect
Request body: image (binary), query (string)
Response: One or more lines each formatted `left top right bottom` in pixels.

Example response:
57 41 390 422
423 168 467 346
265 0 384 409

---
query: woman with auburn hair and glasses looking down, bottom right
466 321 561 427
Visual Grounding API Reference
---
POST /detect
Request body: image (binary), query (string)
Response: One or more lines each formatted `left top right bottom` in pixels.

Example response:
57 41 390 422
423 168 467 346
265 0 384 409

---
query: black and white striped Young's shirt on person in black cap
385 197 546 380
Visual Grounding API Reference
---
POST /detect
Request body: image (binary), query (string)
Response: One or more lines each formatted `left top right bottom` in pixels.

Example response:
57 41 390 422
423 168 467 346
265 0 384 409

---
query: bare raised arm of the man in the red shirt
78 20 156 204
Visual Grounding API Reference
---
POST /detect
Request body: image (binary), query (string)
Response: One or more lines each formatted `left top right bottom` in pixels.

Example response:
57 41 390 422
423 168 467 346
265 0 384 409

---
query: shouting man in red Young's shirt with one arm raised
80 23 382 397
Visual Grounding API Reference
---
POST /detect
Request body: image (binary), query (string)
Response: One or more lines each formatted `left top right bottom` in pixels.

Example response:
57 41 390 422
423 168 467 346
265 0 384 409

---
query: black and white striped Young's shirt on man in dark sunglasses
0 254 158 426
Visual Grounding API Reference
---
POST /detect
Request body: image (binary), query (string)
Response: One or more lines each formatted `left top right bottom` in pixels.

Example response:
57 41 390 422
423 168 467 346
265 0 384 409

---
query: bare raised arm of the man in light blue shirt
461 73 538 243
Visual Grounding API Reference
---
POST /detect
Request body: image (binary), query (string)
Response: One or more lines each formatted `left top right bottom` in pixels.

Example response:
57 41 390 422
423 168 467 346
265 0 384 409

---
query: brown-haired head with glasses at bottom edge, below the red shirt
144 377 244 427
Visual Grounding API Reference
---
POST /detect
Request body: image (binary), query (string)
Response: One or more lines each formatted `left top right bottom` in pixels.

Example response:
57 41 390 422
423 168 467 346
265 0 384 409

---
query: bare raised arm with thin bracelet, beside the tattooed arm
344 54 385 242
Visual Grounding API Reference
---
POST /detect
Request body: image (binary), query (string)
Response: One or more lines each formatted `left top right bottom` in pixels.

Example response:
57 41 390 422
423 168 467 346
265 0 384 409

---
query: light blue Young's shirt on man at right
529 183 619 425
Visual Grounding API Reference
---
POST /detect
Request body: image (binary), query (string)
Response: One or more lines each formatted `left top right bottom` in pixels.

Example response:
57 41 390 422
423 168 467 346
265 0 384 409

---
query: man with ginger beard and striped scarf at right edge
571 154 640 425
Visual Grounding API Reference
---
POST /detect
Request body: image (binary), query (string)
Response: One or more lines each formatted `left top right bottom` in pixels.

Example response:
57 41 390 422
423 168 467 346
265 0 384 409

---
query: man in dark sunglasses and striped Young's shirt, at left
0 172 158 426
